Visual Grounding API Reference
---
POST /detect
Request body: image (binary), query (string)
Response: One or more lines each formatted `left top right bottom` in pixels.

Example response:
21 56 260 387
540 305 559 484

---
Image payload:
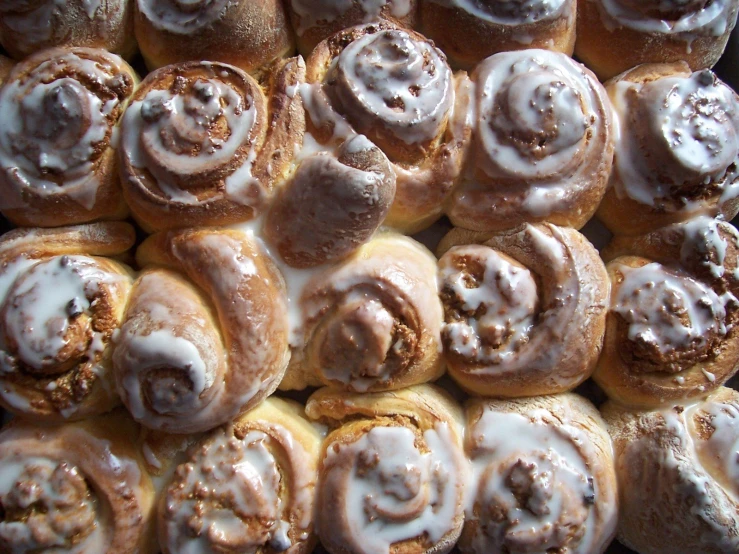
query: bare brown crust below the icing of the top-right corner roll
575 0 736 81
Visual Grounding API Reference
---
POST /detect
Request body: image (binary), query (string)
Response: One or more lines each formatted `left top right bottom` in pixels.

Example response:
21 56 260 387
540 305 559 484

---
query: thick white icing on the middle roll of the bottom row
323 423 463 554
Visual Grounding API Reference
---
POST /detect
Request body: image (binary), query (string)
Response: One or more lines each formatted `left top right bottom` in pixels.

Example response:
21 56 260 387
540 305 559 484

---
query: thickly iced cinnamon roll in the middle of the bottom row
306 385 467 554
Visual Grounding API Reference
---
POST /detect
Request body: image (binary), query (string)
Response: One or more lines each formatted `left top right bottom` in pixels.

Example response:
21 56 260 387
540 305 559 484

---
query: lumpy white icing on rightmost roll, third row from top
611 263 727 353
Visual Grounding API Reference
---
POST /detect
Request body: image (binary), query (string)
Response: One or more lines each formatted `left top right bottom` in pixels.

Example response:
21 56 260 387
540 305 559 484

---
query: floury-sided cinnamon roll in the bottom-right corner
603 387 739 554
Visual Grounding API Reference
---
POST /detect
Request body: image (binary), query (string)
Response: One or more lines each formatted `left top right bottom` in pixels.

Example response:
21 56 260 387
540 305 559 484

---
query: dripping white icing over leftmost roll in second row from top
0 53 119 210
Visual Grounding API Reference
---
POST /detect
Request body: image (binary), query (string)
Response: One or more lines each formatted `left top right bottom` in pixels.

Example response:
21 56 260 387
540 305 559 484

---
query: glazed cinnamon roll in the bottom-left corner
0 413 156 554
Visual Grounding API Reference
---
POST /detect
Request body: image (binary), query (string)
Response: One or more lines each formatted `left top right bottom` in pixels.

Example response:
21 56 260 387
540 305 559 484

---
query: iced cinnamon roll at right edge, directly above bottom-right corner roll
593 256 739 407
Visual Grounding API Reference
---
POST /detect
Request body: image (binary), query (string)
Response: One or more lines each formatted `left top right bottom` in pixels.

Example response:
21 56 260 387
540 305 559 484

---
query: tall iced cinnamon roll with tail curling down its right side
301 23 470 233
